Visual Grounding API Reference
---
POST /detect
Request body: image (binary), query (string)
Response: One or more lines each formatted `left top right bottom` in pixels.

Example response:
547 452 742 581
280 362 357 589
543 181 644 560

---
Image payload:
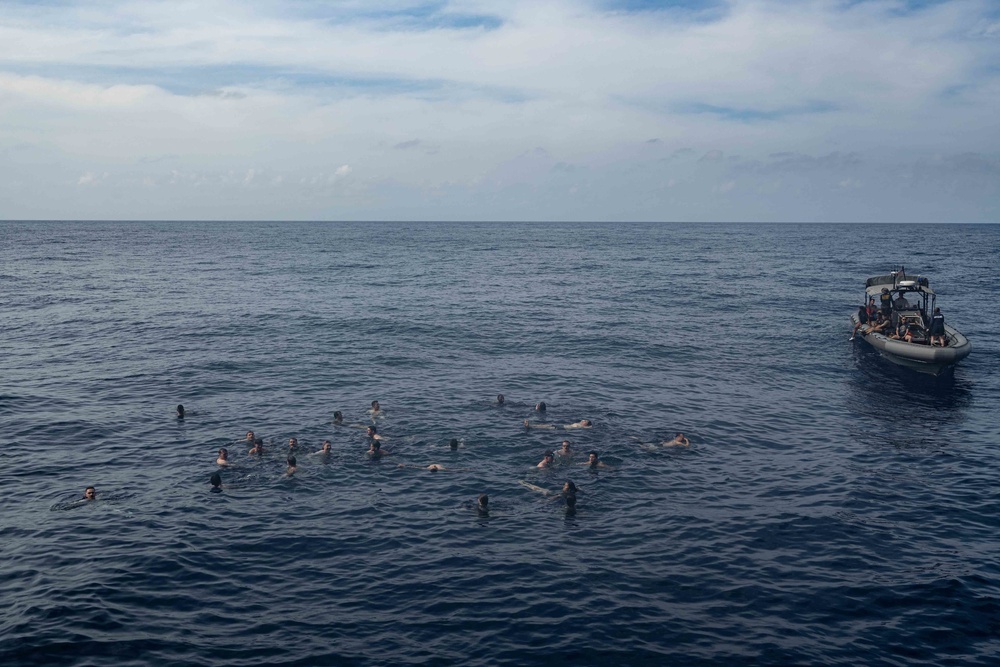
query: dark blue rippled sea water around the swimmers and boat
0 223 1000 666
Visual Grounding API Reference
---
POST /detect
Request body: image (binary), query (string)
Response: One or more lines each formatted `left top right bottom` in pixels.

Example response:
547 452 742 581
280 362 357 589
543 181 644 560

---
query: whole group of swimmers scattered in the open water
83 394 691 515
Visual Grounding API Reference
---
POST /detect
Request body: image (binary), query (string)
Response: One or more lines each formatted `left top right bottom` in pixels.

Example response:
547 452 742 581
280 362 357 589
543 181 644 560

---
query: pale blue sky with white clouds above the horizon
0 0 1000 222
